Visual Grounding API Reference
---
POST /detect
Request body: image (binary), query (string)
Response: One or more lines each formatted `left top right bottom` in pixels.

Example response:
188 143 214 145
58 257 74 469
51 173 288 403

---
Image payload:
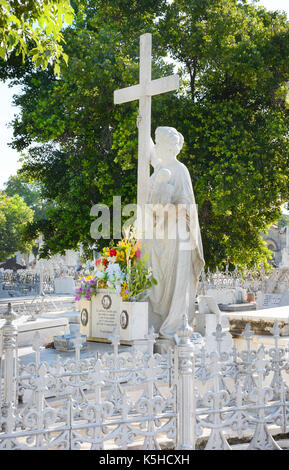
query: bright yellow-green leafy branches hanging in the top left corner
0 0 73 73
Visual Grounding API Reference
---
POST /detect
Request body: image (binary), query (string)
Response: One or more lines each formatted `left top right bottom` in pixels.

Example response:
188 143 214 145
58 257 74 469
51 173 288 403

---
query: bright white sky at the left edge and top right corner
0 0 289 189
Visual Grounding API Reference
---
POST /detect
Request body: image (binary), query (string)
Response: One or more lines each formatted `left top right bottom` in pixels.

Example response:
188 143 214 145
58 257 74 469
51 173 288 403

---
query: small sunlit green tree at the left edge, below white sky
0 193 33 261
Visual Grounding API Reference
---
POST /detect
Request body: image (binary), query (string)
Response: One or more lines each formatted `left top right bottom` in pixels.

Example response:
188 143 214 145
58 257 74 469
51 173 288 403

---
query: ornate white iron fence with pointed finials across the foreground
0 311 289 450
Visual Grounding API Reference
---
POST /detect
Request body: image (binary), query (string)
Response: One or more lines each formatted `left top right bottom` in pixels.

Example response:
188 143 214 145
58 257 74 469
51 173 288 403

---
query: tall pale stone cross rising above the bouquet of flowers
114 33 179 220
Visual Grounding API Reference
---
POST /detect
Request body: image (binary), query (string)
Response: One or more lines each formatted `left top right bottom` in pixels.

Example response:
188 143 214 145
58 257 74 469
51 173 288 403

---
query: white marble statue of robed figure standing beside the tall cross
145 127 204 338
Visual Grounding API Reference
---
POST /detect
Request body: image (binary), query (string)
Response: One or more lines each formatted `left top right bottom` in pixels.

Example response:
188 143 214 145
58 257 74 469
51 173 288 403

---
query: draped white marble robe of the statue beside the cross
145 160 205 338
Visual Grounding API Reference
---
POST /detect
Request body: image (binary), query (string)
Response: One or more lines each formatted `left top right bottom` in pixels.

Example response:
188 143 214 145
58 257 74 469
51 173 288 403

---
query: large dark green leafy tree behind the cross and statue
5 0 289 267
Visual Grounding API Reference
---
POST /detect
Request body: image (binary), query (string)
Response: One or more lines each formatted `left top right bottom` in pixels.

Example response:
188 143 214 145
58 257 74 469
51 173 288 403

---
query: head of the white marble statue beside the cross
155 126 184 160
